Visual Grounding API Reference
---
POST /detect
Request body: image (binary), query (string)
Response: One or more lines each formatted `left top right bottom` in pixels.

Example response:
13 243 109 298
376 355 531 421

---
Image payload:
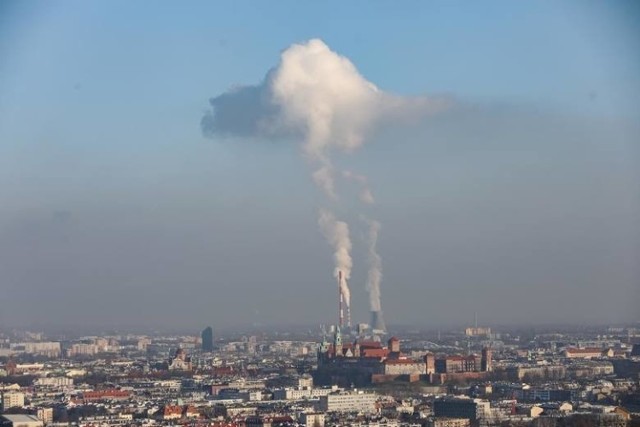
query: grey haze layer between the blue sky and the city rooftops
0 102 640 327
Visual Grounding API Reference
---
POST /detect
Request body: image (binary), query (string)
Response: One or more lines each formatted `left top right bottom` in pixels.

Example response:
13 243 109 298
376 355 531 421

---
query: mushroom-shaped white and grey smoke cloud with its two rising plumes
201 39 449 324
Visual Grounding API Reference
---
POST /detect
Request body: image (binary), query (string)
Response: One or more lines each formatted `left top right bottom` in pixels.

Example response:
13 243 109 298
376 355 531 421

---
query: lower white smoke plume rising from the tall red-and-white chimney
318 209 353 306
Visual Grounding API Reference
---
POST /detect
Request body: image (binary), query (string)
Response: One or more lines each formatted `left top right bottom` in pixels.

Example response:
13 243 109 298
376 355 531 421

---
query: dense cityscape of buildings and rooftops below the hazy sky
0 324 640 427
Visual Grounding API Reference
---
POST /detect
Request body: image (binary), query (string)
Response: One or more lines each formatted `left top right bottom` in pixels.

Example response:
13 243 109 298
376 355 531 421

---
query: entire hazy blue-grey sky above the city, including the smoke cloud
0 1 640 332
